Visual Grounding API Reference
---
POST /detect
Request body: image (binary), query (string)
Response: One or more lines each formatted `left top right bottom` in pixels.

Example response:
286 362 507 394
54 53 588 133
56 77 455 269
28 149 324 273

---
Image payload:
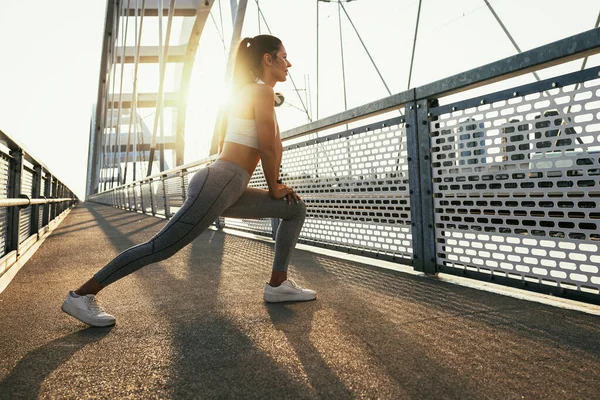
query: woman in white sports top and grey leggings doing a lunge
62 35 316 326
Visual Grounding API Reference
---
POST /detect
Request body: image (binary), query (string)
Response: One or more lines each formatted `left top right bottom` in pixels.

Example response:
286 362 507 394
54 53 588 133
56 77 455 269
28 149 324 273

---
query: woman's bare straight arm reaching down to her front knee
254 85 281 197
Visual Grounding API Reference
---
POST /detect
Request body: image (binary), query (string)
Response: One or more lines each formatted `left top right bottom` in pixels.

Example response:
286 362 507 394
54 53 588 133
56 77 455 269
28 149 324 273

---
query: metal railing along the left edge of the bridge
0 131 78 277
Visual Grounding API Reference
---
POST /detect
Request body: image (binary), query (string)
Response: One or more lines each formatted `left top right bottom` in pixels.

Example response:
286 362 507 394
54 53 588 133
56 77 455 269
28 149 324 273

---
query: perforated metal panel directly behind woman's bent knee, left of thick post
226 119 412 260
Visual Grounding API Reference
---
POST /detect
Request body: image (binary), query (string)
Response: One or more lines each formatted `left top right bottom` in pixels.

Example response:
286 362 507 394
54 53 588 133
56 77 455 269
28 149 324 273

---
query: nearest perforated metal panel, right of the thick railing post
430 75 600 293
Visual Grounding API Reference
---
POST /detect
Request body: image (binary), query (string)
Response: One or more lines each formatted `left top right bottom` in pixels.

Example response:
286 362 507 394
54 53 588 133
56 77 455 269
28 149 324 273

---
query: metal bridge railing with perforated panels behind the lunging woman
90 29 600 302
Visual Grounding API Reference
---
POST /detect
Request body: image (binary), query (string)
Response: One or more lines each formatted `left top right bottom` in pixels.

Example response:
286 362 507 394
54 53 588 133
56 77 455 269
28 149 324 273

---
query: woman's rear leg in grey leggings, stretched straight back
81 167 247 295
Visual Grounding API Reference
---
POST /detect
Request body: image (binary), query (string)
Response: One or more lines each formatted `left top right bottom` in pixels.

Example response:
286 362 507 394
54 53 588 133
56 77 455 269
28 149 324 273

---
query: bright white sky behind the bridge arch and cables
0 0 600 198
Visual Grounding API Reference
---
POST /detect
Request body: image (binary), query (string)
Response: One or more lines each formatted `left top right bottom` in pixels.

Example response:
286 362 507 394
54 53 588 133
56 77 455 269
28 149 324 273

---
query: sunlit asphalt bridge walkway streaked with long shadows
0 203 600 399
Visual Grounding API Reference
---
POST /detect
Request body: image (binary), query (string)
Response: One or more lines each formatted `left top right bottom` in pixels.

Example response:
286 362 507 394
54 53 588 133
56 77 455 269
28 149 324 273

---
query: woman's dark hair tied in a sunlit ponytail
232 35 281 92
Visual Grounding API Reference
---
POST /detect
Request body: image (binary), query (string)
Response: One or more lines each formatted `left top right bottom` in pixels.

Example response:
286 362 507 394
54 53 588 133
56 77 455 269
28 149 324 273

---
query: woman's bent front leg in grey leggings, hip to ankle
222 188 306 286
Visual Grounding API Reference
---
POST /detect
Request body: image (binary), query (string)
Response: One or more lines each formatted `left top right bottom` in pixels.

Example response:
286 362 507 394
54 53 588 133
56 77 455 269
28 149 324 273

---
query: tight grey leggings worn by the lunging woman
94 160 306 287
